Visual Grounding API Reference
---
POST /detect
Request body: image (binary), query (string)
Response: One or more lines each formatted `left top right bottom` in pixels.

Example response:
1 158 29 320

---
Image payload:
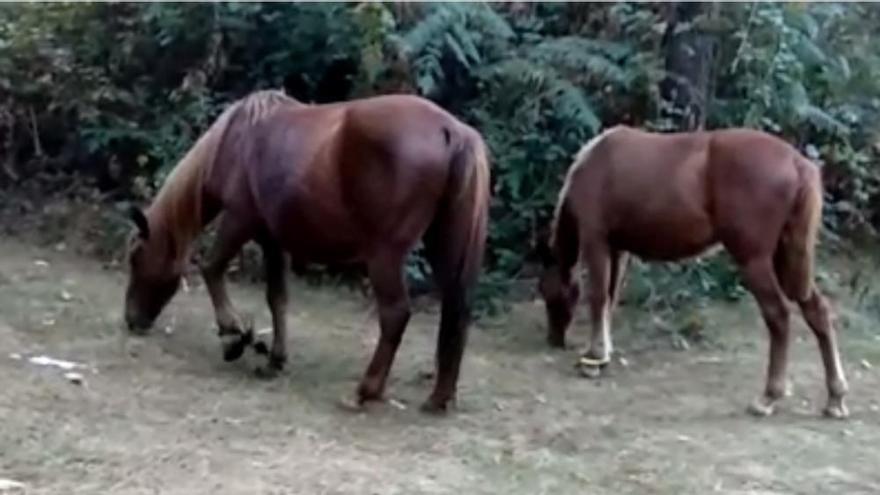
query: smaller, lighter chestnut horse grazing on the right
539 127 847 417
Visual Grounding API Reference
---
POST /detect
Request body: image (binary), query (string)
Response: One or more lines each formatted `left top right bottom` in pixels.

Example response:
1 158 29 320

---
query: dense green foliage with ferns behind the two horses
0 3 880 310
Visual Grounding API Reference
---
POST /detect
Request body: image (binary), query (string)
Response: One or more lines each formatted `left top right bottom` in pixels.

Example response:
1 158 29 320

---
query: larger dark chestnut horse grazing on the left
125 91 489 411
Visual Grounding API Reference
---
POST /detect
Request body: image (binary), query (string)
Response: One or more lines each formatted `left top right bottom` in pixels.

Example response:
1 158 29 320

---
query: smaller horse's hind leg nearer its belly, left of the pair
740 257 789 416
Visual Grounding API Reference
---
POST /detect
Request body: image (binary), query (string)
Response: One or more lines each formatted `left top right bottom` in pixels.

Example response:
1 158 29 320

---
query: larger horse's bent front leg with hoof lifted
202 215 253 361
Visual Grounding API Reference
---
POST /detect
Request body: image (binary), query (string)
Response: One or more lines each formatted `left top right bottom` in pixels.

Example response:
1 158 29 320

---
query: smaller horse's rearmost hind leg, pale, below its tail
799 287 849 418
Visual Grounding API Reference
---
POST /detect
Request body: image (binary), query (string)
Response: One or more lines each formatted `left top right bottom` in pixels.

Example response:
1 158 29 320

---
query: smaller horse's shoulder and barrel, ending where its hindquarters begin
568 127 714 259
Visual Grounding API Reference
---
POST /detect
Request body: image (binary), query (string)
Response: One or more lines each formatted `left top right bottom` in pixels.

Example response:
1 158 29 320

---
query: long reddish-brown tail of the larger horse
425 127 490 297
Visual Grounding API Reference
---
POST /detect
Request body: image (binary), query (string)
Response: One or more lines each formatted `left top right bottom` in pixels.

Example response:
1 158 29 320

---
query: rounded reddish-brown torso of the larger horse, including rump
237 95 463 261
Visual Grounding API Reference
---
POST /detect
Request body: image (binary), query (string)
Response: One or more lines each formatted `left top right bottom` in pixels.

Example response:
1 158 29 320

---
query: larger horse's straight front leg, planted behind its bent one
258 241 287 378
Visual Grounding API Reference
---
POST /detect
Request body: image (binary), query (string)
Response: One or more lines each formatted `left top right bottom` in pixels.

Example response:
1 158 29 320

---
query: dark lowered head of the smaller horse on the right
537 241 581 347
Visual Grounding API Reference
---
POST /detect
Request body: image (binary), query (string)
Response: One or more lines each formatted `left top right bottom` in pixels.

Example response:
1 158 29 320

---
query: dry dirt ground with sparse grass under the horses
0 238 880 495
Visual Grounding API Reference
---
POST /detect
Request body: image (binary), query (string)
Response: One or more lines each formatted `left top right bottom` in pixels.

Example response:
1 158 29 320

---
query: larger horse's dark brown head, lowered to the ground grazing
125 208 183 331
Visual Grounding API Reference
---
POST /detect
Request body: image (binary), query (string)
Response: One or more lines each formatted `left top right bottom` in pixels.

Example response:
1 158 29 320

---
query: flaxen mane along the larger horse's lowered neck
146 90 302 258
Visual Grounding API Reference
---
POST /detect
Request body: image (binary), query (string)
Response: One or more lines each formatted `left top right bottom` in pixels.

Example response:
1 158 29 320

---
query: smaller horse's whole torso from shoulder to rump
568 127 797 259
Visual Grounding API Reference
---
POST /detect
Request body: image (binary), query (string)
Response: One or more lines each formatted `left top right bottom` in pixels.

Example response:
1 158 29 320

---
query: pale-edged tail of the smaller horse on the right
776 158 822 301
